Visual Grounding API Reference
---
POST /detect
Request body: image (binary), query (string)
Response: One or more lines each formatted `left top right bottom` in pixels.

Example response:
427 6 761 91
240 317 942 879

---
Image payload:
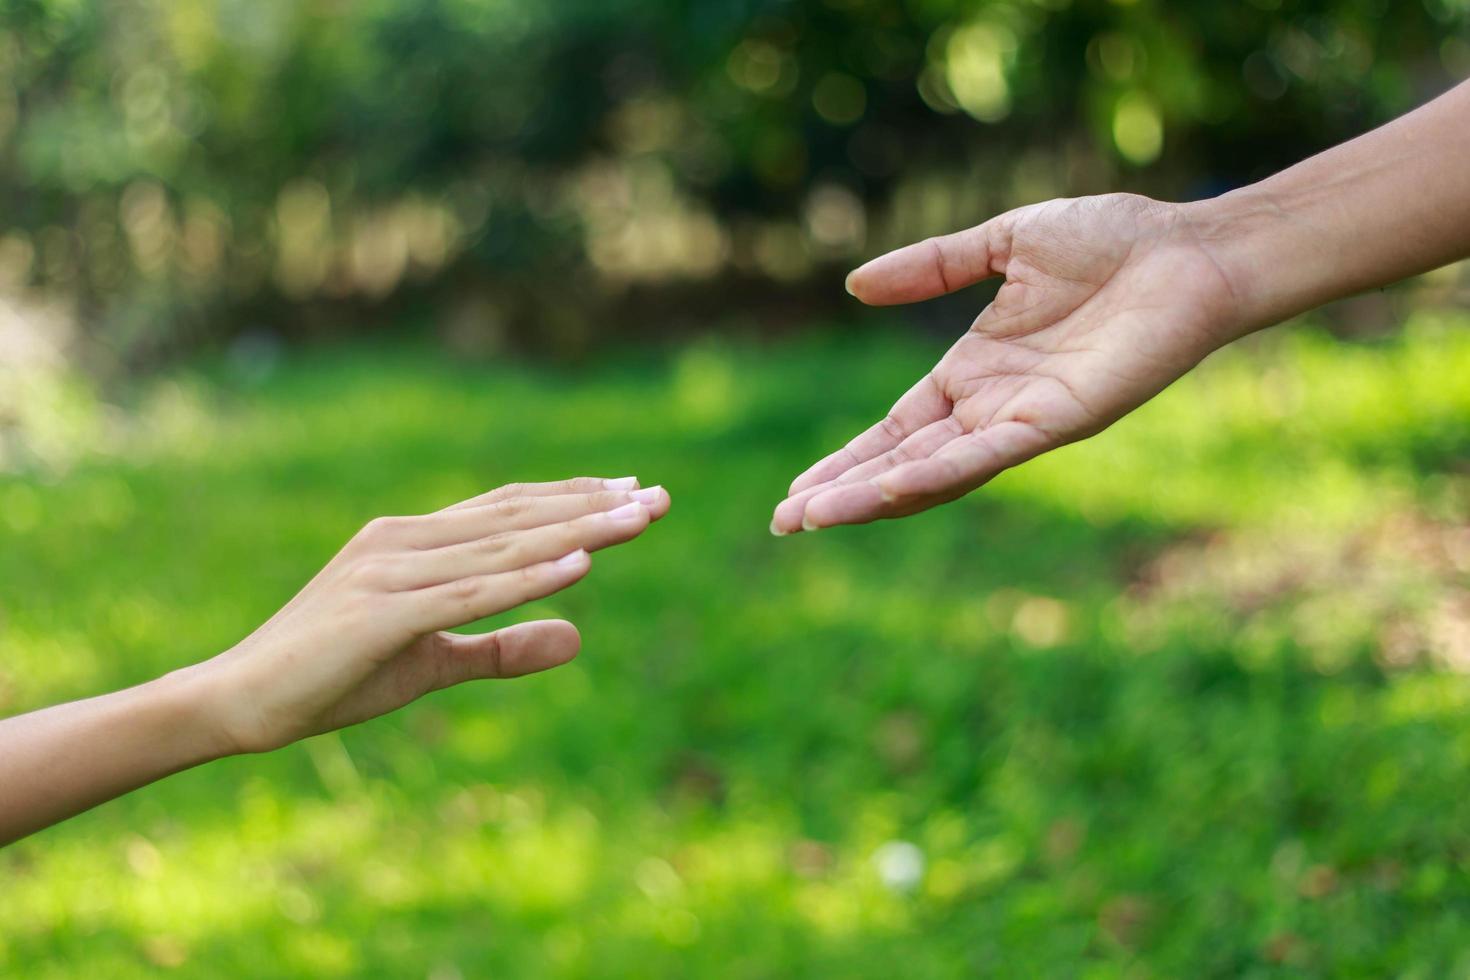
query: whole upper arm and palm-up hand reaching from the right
770 82 1470 535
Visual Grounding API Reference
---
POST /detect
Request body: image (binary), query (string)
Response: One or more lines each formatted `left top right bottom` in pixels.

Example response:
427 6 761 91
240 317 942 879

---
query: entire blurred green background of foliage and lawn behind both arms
0 0 1470 980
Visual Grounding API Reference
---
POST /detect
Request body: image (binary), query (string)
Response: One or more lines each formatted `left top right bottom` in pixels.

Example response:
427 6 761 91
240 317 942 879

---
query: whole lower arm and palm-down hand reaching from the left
0 478 669 846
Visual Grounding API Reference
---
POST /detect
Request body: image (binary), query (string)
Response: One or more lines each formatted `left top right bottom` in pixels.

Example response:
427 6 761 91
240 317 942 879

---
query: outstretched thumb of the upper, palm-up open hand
847 213 1011 306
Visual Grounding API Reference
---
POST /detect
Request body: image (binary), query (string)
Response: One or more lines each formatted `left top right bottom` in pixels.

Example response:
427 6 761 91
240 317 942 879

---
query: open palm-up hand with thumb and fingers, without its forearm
772 194 1235 533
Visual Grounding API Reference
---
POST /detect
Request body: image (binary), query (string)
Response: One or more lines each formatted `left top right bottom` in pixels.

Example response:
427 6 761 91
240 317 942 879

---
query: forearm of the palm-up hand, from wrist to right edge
1185 82 1470 335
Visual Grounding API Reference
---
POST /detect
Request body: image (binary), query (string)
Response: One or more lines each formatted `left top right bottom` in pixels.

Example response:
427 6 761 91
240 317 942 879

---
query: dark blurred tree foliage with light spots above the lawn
0 0 1470 361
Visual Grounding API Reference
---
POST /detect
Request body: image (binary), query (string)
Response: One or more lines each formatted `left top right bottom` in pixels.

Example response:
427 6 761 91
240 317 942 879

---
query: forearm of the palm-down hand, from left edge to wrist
0 669 225 846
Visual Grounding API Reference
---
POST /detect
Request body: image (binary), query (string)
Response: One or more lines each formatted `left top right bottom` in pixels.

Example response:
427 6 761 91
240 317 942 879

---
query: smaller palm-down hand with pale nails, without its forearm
198 478 670 752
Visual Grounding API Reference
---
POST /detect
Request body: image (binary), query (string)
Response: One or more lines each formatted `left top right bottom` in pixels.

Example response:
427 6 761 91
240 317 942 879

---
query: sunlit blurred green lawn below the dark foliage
0 316 1470 980
